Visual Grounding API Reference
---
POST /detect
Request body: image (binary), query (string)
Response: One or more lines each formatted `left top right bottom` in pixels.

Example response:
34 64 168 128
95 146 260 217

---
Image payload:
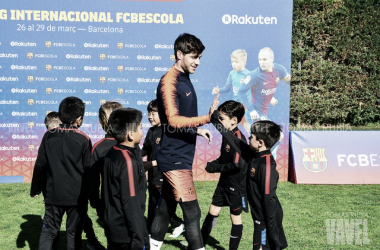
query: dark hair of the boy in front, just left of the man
108 108 142 143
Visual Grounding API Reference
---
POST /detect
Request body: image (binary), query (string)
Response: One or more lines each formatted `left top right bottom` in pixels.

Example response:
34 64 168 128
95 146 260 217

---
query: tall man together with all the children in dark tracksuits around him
30 33 287 250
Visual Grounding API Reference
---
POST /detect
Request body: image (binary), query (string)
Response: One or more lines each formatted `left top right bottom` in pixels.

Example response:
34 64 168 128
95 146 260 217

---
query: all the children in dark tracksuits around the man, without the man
31 97 286 250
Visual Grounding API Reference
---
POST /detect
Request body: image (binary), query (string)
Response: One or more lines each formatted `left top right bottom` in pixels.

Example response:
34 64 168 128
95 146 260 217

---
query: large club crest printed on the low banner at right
302 148 328 173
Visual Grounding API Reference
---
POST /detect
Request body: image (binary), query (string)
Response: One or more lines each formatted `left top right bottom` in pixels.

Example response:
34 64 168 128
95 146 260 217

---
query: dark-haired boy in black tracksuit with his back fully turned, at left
35 97 92 250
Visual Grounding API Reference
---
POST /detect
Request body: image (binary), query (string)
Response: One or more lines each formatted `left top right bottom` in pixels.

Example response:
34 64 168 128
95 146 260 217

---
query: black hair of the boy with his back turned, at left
58 96 85 125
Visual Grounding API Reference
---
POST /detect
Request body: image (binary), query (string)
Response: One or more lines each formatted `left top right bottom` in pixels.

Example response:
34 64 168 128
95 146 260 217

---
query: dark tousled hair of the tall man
174 33 205 60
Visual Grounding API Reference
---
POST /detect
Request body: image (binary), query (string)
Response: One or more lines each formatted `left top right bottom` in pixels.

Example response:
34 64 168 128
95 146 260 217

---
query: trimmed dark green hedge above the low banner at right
290 0 380 126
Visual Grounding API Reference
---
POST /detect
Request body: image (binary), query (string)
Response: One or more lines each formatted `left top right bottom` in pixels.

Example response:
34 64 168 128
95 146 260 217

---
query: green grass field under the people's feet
0 182 380 250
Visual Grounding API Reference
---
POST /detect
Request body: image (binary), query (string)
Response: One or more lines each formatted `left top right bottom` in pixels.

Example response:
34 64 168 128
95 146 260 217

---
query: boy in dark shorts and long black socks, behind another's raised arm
202 101 248 249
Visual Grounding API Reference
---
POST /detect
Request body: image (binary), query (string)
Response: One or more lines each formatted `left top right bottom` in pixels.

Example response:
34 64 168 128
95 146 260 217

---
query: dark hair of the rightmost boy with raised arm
251 121 281 149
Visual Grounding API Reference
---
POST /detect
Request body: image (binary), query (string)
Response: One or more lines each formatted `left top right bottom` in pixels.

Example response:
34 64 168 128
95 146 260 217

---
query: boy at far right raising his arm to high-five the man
211 112 288 250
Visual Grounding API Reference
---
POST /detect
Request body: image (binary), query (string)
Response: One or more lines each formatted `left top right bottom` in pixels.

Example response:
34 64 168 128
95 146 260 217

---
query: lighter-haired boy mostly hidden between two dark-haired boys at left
90 101 123 216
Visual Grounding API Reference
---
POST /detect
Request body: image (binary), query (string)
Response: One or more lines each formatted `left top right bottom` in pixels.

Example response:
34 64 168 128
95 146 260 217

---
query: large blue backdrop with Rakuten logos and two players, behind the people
0 0 293 182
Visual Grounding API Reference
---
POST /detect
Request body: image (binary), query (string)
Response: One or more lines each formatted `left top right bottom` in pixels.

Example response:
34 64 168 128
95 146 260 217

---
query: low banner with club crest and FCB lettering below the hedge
290 131 380 184
